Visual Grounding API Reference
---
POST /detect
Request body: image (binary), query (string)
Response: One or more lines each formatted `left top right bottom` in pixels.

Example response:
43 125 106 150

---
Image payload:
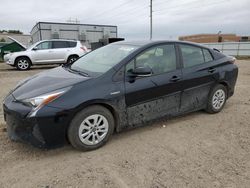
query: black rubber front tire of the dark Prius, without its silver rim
68 105 115 151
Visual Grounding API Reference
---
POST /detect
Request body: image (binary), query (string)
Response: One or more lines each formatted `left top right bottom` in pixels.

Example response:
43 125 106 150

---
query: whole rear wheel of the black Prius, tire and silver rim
206 84 227 114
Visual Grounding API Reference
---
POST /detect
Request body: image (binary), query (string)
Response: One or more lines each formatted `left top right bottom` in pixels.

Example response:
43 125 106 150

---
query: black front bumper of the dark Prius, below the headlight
3 94 70 148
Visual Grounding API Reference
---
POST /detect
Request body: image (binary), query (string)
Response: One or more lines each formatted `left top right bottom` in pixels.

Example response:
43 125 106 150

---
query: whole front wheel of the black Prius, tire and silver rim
68 105 114 151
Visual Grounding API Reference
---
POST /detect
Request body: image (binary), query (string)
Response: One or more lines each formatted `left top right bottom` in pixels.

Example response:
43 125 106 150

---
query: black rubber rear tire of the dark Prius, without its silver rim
206 84 227 114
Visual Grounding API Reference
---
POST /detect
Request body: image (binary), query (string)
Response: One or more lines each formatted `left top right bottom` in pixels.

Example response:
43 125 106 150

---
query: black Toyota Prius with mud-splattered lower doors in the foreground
3 41 238 150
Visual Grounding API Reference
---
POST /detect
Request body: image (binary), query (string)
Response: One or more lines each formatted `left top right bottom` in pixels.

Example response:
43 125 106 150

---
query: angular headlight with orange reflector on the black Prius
21 87 71 117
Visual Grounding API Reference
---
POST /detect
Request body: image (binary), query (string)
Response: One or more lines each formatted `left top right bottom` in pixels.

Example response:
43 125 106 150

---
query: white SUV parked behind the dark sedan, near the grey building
4 39 88 70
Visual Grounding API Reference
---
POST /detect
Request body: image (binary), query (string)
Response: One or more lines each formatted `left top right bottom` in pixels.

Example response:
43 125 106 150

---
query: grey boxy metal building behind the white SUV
31 22 117 48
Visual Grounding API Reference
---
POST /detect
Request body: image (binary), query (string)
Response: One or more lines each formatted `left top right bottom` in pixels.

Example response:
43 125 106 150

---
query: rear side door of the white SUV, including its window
52 41 70 63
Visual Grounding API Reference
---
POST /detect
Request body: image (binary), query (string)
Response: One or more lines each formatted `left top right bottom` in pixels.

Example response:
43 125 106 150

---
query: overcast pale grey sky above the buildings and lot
0 0 250 40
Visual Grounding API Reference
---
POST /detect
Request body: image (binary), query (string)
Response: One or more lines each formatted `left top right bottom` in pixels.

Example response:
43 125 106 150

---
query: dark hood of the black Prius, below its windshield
12 67 90 100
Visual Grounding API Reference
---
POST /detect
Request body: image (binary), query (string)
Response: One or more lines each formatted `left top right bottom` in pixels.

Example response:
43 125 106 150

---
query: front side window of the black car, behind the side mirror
126 44 176 74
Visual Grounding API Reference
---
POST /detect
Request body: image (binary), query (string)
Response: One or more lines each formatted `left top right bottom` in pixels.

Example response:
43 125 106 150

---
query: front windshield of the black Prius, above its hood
70 44 138 76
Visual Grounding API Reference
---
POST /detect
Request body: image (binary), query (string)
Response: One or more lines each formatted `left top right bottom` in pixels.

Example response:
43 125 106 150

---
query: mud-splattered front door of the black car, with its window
125 43 182 126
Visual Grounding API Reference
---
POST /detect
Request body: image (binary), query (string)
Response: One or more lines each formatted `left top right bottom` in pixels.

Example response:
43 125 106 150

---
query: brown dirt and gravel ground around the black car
0 60 250 188
